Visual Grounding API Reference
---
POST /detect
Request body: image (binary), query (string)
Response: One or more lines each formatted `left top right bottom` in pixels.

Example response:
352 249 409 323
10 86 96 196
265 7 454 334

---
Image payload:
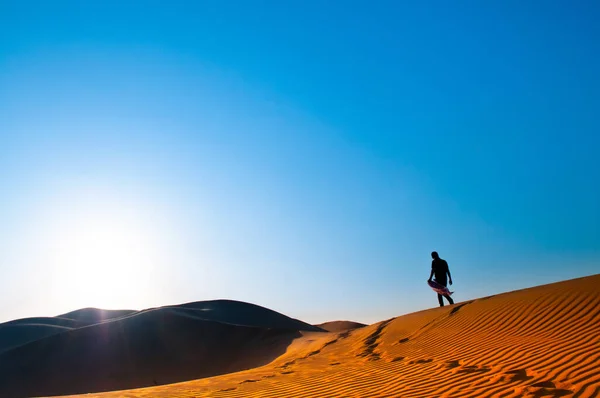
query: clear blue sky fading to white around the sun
0 0 600 323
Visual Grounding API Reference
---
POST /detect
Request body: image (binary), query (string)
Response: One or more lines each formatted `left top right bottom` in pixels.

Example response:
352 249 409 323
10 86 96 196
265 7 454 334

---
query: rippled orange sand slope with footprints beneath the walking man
74 275 600 398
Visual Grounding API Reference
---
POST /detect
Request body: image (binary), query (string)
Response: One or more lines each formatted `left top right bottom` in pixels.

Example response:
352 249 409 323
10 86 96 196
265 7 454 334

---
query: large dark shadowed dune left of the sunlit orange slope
0 300 324 397
